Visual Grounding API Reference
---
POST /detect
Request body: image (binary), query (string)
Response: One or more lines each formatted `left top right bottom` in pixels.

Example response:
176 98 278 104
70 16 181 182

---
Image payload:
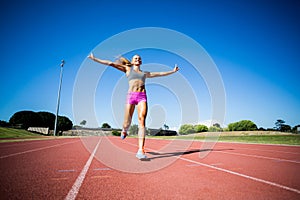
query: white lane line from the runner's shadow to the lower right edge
179 157 300 194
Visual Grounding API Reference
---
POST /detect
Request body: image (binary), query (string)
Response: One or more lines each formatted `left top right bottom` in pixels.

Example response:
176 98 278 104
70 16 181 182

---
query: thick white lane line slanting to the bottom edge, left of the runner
65 138 101 200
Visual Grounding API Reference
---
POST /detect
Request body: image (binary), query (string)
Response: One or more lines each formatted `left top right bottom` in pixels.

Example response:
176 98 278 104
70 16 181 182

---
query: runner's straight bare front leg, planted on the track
138 101 148 151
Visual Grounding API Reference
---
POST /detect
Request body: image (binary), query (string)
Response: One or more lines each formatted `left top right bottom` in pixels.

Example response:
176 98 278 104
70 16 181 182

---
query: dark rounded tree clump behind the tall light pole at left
0 110 73 132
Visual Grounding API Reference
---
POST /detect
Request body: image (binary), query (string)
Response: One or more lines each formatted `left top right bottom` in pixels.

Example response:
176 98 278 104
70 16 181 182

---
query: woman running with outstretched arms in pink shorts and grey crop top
88 53 179 160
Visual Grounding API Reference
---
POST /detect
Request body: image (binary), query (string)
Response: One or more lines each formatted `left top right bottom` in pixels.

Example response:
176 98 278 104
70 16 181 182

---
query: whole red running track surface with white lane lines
0 137 300 200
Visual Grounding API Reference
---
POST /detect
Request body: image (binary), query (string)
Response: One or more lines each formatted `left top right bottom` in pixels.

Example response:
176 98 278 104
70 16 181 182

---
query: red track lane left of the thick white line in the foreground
0 139 95 199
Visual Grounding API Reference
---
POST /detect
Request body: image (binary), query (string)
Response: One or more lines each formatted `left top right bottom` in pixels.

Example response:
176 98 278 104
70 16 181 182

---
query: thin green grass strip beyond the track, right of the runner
150 134 300 145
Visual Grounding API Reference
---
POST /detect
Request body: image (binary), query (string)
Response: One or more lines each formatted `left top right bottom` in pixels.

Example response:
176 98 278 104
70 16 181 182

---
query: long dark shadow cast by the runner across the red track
147 149 234 161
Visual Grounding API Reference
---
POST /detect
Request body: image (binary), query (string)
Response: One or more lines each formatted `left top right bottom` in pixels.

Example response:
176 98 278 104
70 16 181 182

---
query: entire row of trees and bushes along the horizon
0 111 300 134
